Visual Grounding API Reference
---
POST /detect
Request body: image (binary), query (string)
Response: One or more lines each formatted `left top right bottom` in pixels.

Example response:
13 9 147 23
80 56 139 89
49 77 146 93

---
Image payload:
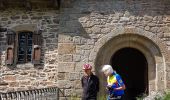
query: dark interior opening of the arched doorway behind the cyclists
111 48 148 100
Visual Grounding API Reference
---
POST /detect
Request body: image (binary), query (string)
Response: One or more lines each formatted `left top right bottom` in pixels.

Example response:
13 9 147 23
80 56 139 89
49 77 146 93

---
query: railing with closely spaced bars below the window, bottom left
0 87 59 100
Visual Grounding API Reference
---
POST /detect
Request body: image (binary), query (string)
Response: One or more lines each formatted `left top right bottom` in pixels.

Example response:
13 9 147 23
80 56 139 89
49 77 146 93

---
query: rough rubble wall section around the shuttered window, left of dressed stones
0 9 59 92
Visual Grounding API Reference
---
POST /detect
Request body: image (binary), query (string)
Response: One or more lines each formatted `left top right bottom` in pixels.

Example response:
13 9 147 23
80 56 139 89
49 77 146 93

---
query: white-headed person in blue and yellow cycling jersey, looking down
102 65 126 100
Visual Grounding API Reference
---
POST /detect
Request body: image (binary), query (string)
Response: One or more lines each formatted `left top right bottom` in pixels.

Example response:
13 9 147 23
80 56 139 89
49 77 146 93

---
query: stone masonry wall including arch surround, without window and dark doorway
0 0 170 97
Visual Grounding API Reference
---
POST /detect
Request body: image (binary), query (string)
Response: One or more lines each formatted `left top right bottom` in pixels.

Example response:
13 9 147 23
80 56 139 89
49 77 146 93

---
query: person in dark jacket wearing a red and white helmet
81 64 99 100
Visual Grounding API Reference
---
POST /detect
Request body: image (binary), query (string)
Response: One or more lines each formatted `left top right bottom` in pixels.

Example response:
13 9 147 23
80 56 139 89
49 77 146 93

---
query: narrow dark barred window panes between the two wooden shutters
18 32 33 63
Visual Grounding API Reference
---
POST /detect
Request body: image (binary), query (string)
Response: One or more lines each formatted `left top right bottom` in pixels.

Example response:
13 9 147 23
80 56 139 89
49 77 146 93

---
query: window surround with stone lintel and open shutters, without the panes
6 24 43 68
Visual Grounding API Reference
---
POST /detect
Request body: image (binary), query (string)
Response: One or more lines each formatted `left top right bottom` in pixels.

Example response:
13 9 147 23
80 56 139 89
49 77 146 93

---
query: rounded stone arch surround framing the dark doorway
89 28 169 98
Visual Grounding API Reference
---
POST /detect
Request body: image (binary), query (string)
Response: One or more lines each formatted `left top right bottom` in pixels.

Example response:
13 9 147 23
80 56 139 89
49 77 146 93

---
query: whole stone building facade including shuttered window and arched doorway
0 0 170 98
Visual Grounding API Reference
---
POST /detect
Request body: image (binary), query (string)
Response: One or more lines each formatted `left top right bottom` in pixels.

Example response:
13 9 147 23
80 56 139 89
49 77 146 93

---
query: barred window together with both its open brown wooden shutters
6 30 42 65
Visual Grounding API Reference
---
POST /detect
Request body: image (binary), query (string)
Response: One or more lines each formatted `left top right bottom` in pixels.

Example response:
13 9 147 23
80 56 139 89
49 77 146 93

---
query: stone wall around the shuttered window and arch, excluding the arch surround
0 0 170 96
